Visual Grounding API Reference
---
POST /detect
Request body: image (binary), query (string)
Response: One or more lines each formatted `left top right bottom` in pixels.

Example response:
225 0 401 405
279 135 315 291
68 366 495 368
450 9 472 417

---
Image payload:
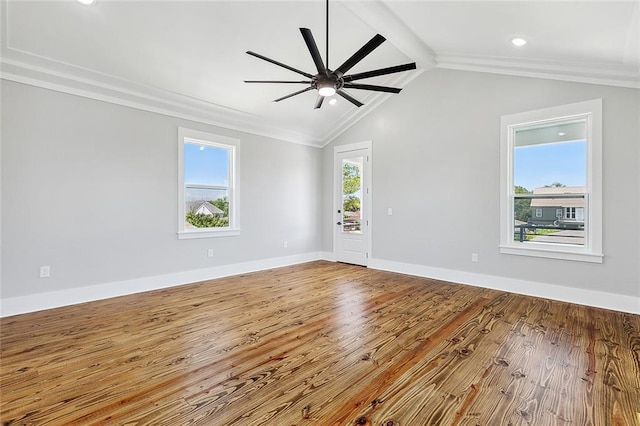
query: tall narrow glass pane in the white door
342 156 364 234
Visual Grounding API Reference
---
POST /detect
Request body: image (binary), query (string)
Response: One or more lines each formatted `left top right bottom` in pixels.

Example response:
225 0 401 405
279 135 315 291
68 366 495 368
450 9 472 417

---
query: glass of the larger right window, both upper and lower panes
513 120 587 245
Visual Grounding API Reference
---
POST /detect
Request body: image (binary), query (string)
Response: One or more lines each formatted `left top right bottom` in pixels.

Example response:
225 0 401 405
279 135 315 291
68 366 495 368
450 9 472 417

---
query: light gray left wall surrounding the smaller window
1 81 322 298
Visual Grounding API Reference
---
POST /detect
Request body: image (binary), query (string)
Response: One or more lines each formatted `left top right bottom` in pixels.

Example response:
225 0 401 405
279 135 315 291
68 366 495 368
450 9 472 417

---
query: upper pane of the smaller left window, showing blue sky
184 142 229 187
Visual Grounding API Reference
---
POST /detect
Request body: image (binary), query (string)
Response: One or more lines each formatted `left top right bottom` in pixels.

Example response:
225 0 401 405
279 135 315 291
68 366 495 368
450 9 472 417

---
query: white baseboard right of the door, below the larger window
368 259 640 314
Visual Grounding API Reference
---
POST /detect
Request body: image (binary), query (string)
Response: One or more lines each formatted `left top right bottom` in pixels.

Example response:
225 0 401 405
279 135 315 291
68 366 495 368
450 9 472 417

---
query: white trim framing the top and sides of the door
331 140 373 267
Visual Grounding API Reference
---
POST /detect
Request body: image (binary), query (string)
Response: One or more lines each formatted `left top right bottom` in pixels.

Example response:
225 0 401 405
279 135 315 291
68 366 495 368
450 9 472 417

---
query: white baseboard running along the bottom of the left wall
0 252 323 318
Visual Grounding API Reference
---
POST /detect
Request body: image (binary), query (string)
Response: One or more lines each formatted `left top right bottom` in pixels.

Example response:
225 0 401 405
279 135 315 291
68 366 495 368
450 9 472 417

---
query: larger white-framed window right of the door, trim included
500 99 603 263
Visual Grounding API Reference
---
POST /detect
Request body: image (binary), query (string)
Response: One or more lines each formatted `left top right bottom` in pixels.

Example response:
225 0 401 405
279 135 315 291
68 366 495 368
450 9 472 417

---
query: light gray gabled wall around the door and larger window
322 69 640 296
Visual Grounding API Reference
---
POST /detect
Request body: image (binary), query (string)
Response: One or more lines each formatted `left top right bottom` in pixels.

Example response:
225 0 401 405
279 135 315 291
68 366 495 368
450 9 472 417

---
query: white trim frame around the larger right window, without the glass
500 99 604 263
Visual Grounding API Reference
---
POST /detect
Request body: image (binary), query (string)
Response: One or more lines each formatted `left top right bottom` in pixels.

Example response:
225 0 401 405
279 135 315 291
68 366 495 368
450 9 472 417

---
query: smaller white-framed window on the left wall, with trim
178 127 240 239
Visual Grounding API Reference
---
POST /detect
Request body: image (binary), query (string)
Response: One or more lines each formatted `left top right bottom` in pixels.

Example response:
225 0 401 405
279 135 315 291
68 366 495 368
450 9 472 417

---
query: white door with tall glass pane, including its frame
333 142 371 266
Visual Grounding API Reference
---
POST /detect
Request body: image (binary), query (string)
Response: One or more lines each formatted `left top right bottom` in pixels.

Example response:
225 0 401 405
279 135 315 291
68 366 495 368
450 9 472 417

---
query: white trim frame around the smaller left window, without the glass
178 127 240 240
